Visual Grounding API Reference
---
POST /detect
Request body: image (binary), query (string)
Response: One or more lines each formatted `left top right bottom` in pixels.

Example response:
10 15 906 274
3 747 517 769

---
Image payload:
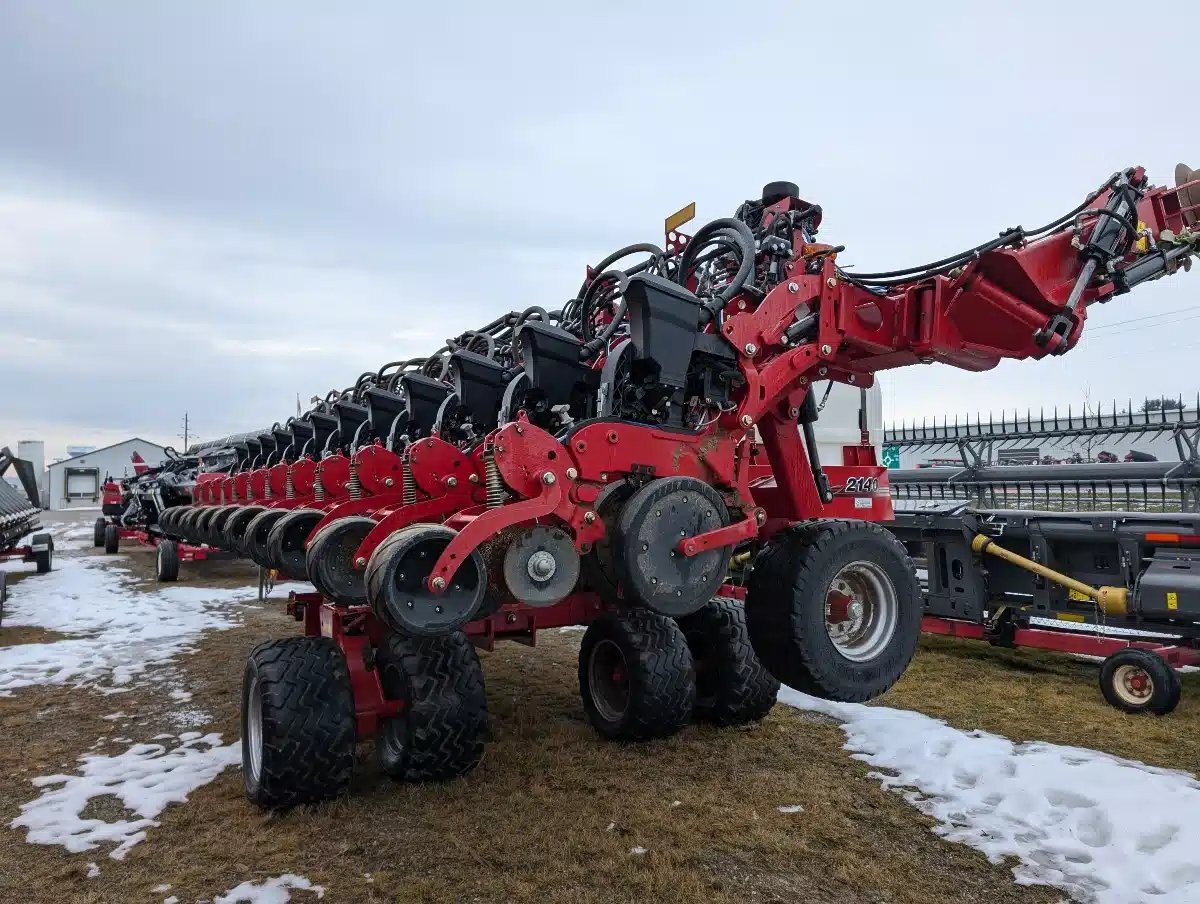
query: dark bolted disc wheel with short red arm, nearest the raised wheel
613 477 733 617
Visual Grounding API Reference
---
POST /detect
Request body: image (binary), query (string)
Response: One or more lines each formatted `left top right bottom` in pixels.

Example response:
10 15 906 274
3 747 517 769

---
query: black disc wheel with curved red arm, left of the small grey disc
366 525 487 636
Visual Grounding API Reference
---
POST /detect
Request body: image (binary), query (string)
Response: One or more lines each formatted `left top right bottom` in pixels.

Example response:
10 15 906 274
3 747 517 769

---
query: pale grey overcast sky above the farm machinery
0 0 1200 457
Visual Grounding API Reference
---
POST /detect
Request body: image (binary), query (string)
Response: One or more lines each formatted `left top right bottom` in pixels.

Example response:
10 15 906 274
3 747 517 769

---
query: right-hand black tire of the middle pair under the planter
679 599 779 725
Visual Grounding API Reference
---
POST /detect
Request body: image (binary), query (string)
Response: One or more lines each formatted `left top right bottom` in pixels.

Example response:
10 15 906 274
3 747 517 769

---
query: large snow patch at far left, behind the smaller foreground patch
0 558 254 696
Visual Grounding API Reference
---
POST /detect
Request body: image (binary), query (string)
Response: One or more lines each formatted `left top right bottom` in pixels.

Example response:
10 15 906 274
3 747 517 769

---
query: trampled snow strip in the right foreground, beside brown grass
779 688 1200 904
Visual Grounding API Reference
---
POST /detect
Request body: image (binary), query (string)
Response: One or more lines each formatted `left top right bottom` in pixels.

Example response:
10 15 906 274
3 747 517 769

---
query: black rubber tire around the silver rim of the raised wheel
745 520 923 702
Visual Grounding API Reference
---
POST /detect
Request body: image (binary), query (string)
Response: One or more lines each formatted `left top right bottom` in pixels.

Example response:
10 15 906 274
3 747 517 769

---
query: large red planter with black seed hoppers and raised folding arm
218 167 1200 807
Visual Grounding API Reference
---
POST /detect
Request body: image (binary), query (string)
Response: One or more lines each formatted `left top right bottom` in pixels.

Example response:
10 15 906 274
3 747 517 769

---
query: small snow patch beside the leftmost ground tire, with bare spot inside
10 732 241 860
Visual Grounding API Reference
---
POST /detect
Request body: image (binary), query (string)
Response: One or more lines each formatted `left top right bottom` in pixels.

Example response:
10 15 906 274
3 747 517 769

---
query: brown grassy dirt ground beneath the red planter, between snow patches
0 513 1200 904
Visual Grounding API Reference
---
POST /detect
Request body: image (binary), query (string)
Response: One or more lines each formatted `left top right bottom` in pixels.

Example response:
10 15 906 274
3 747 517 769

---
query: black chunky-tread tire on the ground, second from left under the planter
376 631 487 782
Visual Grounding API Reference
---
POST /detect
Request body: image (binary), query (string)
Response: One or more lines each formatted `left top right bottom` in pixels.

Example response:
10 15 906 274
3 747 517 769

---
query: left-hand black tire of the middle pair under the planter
580 609 696 741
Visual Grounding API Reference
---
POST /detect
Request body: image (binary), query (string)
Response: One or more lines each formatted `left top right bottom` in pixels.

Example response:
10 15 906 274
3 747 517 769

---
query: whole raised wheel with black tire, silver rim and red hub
745 520 922 702
